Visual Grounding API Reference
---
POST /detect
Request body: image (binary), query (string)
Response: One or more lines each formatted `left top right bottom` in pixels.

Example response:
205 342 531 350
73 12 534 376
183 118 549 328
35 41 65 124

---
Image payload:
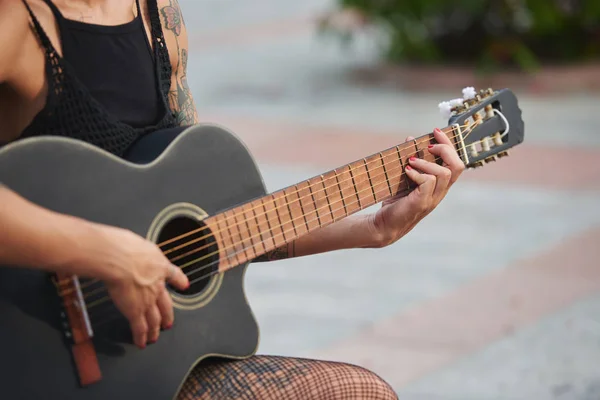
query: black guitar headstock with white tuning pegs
439 87 525 168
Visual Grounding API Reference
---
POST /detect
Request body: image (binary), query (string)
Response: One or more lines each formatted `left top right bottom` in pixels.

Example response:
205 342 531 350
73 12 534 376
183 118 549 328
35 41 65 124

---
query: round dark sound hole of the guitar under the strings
158 217 219 295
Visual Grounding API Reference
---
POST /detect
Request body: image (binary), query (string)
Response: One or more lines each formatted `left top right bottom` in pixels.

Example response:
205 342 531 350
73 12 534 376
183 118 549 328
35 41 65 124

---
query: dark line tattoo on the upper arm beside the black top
160 0 198 126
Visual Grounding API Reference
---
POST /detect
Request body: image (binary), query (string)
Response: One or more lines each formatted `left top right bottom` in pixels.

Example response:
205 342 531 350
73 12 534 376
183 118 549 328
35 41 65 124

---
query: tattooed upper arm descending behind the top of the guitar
158 0 199 126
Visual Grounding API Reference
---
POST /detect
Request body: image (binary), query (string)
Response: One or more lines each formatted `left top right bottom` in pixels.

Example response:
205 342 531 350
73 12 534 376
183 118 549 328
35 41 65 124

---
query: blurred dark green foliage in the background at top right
326 0 600 71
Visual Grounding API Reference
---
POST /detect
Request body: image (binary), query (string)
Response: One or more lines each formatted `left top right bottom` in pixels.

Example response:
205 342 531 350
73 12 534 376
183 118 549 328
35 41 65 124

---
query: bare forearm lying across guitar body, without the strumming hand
0 185 118 279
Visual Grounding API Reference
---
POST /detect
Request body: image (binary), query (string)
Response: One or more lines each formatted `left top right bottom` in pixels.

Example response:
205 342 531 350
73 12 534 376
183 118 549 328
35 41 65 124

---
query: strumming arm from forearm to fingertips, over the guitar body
0 186 189 348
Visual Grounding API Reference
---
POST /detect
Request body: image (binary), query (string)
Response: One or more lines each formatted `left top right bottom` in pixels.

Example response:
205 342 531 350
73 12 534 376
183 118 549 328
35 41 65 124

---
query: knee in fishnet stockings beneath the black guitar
177 356 398 400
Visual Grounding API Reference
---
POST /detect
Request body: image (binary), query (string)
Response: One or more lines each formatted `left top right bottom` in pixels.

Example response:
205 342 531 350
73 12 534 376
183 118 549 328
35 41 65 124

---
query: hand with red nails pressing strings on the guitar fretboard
370 128 465 247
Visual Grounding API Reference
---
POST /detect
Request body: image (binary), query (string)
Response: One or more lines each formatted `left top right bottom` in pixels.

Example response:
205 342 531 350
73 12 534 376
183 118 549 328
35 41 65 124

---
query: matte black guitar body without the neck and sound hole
0 126 265 400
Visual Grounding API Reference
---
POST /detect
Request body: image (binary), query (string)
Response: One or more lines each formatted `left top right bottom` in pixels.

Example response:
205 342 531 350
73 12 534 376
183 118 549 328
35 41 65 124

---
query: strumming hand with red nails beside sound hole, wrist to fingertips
97 227 189 348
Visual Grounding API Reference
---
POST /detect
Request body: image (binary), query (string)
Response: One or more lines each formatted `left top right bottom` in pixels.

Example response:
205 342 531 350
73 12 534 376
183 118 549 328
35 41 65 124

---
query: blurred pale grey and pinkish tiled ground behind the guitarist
180 0 600 400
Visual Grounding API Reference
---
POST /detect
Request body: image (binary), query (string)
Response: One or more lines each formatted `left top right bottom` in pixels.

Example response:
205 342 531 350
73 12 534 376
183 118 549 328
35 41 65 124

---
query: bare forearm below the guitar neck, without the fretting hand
254 215 381 262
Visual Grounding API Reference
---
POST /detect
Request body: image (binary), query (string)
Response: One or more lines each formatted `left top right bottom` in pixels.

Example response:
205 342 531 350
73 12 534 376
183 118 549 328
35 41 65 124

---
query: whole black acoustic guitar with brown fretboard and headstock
0 88 524 400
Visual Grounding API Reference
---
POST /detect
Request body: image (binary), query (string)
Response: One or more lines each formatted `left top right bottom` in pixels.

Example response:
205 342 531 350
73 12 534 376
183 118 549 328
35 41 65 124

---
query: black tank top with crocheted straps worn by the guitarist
21 0 177 156
